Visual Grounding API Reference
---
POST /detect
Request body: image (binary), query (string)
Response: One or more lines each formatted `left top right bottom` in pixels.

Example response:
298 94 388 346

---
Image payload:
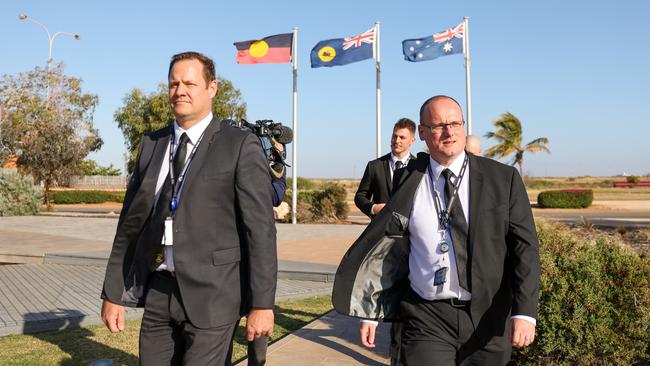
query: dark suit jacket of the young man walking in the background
354 153 415 217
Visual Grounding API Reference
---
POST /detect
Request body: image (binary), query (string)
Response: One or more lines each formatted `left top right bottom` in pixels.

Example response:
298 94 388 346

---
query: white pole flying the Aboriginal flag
291 27 298 224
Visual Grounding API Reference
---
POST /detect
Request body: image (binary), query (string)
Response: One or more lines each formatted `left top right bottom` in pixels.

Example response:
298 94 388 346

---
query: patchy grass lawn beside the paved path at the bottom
0 296 332 366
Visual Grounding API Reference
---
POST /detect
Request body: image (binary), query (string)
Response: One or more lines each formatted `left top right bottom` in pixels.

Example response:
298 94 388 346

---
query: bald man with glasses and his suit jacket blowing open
332 96 540 366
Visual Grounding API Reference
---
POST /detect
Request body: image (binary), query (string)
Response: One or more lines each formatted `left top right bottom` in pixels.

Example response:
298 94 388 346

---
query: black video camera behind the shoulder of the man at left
228 118 293 179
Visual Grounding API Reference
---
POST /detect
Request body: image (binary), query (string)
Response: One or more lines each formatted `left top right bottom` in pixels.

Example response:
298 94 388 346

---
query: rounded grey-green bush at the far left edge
0 169 43 216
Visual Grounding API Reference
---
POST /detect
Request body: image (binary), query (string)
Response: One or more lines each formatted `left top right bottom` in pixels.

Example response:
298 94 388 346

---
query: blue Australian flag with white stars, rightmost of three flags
402 23 465 62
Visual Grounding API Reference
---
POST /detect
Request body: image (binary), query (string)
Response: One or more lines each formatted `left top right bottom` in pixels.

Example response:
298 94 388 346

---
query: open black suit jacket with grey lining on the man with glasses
332 153 540 339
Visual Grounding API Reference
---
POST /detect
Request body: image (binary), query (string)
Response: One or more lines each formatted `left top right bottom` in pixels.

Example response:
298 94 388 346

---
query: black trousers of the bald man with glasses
400 290 512 366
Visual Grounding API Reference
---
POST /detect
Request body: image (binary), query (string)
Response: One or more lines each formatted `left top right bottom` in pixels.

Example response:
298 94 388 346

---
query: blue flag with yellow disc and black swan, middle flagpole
310 27 375 68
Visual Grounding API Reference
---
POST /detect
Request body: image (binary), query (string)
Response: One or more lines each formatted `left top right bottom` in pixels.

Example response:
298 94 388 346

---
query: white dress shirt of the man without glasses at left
154 112 212 272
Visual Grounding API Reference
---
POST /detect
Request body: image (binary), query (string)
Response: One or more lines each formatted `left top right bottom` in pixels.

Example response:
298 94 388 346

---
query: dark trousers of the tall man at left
140 271 237 366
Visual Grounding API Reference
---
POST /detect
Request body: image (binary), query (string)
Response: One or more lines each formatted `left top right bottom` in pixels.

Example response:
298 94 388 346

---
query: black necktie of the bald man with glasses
442 169 471 291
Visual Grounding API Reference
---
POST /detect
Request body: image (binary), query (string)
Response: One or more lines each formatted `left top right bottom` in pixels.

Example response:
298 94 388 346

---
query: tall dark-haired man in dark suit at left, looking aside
102 52 277 365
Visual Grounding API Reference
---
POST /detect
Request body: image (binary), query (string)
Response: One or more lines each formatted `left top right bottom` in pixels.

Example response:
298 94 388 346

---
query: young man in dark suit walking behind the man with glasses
354 118 415 218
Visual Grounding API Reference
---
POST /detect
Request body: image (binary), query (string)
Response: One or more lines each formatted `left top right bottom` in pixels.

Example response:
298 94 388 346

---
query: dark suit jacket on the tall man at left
102 119 277 327
